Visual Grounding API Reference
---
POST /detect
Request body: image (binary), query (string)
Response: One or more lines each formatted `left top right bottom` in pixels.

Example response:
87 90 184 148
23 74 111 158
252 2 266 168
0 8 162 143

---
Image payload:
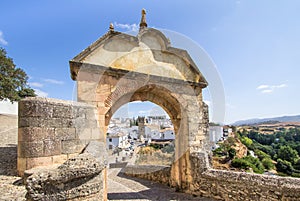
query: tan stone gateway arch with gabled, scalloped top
70 12 208 199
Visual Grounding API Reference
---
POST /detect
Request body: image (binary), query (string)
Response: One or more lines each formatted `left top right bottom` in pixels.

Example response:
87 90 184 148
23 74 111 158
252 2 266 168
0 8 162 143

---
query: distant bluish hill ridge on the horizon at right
233 115 300 126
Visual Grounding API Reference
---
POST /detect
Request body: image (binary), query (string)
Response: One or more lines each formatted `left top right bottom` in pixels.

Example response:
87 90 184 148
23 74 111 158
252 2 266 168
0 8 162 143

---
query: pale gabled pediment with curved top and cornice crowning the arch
69 9 208 88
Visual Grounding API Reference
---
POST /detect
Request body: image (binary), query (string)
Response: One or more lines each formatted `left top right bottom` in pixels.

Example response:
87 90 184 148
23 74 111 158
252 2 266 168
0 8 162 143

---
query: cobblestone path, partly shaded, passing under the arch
107 169 213 201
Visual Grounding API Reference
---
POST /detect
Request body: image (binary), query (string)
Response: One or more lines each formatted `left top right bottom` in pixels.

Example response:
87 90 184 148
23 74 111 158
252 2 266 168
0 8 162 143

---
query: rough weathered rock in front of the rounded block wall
26 153 105 200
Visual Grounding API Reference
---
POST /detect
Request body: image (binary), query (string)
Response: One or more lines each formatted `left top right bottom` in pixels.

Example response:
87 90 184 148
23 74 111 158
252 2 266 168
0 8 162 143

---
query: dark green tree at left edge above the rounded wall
0 47 36 102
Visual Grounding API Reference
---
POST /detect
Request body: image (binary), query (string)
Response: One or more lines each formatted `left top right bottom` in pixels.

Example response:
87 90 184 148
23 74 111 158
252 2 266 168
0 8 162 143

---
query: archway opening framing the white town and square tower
106 101 176 166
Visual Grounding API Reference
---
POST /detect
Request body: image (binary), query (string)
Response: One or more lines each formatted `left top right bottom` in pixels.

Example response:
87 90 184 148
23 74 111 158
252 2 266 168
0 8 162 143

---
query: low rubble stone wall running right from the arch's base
186 153 300 201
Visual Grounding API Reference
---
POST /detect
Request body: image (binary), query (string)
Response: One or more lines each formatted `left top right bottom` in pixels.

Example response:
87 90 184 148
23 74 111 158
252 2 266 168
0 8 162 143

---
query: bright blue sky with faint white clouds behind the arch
0 0 300 122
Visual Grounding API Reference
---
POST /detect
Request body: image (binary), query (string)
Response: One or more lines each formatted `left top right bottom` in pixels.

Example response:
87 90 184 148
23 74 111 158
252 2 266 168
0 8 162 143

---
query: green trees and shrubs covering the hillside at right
214 125 300 177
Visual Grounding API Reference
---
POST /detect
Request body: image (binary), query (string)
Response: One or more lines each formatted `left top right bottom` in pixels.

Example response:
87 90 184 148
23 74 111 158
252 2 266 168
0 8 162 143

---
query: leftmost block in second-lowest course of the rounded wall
18 141 44 158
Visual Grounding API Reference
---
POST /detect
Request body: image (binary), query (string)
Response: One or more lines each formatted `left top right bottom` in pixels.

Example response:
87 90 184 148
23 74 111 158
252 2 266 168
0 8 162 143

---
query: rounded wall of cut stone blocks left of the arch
18 97 104 176
